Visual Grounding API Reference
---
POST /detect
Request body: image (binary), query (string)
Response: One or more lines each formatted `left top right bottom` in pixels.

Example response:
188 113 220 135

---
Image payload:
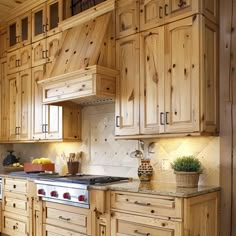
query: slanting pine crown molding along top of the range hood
59 0 115 31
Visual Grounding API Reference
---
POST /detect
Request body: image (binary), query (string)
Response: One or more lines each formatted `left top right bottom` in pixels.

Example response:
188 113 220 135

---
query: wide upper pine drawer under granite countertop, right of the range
111 192 183 218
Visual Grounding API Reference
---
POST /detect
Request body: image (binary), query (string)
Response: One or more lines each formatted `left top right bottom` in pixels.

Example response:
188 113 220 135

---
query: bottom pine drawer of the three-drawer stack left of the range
2 211 29 236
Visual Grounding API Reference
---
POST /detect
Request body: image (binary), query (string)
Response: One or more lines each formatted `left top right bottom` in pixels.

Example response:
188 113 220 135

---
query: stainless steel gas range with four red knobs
35 175 128 208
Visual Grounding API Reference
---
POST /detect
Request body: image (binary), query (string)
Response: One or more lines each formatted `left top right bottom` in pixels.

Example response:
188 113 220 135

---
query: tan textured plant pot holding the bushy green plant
174 171 201 188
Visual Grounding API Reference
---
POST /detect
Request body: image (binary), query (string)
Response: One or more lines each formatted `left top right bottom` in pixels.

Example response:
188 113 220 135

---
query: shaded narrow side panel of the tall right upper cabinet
201 17 219 133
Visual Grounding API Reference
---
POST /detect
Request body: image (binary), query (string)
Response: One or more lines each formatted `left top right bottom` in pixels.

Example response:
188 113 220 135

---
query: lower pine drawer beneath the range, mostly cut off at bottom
43 224 85 236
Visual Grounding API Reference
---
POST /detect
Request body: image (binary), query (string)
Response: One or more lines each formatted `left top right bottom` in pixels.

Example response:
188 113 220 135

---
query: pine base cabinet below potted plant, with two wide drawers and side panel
111 191 219 236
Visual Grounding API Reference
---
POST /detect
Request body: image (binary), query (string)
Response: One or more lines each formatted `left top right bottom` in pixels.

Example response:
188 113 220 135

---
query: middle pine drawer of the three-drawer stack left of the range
2 192 29 216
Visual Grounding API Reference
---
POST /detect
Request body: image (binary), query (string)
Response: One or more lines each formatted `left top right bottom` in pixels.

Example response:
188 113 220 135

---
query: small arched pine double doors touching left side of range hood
32 33 62 67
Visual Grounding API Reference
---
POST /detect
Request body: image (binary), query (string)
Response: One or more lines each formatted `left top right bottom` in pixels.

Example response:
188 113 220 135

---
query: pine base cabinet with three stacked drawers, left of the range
2 177 39 236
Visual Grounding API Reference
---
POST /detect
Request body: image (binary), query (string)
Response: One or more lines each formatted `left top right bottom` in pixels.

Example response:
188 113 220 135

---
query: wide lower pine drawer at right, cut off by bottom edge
111 212 182 236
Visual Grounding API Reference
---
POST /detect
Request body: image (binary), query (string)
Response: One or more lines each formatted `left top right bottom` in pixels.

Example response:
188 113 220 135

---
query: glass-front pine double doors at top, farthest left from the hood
8 12 31 50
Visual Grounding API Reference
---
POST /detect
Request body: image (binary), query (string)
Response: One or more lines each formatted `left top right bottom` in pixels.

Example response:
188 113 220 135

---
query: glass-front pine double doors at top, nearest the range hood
32 0 62 42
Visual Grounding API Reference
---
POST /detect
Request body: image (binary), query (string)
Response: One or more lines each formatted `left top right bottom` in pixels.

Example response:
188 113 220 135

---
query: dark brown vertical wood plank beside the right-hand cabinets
220 0 233 236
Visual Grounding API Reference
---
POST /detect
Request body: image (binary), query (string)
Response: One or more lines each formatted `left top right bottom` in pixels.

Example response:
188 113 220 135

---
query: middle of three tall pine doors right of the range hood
140 27 164 134
